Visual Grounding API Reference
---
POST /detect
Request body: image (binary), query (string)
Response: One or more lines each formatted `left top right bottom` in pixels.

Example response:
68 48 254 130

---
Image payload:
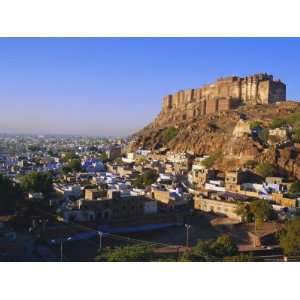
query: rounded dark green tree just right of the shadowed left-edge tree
20 172 52 195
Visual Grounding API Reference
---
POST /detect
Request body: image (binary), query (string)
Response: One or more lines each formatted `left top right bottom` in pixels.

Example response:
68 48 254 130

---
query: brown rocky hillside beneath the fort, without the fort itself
132 96 300 178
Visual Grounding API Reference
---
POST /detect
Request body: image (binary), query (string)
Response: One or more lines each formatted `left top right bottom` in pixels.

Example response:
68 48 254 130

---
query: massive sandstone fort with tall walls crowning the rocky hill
155 73 286 124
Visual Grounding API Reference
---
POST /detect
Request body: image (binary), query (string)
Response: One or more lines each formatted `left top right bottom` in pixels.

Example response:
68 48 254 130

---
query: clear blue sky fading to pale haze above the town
0 38 300 136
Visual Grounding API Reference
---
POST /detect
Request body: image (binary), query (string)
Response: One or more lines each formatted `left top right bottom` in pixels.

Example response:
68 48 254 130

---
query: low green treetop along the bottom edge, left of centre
95 244 153 262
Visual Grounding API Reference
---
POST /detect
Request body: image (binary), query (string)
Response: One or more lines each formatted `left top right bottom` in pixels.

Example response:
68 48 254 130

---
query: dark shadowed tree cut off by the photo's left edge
0 174 23 213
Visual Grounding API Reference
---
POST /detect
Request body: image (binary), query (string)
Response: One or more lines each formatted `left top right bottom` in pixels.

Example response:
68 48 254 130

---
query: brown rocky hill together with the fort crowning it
131 74 300 178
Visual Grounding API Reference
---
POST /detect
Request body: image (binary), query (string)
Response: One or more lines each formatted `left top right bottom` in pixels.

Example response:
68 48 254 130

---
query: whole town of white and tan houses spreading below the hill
0 130 300 254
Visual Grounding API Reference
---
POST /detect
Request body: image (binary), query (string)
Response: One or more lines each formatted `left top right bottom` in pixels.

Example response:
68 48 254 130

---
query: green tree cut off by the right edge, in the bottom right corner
279 217 300 256
